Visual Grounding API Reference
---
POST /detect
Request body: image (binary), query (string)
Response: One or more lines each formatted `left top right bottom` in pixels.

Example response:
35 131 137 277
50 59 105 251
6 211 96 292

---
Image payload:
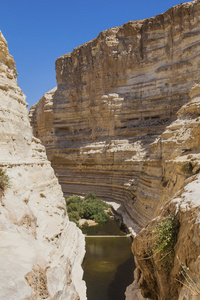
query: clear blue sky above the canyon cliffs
0 0 189 106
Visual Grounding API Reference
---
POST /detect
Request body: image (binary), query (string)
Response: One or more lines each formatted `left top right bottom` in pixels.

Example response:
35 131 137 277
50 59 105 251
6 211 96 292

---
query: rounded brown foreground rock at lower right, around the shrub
131 175 200 300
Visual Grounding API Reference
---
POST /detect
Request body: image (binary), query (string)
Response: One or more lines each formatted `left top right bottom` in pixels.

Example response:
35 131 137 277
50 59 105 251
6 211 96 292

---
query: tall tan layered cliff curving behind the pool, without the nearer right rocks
30 1 200 231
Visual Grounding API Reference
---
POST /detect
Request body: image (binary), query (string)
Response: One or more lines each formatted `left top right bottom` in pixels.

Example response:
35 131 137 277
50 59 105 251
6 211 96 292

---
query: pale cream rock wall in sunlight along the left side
0 33 86 300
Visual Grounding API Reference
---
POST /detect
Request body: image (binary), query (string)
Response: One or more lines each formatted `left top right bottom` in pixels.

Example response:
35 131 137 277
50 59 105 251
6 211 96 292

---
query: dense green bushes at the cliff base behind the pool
66 193 109 225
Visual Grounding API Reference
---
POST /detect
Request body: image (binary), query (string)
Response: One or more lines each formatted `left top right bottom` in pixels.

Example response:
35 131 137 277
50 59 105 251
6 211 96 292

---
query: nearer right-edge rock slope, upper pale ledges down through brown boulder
127 80 200 300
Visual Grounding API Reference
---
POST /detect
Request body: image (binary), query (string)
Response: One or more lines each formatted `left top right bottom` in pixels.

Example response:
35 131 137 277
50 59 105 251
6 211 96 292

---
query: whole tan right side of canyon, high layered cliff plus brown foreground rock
30 1 200 300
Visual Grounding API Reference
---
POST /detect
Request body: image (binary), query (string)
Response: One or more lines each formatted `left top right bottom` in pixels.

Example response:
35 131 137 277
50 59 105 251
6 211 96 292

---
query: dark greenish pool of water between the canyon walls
83 220 135 300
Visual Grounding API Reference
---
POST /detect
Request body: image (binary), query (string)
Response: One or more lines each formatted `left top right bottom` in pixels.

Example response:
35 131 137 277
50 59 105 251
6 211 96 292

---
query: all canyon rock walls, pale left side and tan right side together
0 0 200 300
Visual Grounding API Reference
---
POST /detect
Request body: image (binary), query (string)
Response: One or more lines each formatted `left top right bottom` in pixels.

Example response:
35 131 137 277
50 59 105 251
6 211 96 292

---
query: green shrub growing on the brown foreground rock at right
152 215 179 269
